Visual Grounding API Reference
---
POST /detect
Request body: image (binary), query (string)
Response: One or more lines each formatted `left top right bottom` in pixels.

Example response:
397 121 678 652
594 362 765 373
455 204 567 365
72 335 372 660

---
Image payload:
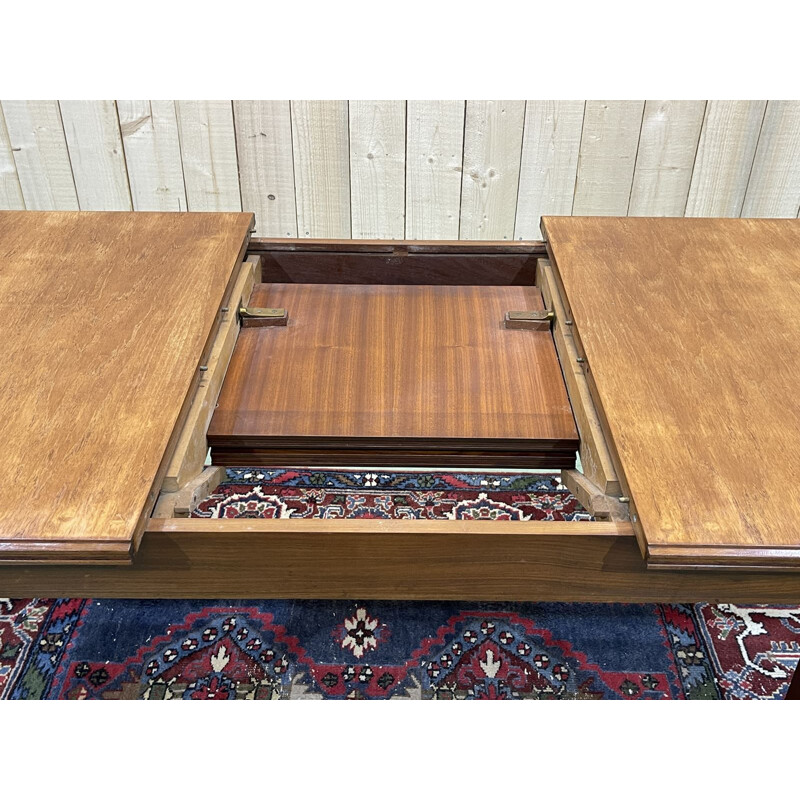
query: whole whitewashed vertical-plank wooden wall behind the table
0 100 800 239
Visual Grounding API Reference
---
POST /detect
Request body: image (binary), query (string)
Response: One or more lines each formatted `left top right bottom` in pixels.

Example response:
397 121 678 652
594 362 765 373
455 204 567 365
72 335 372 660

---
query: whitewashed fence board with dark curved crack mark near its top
117 100 186 211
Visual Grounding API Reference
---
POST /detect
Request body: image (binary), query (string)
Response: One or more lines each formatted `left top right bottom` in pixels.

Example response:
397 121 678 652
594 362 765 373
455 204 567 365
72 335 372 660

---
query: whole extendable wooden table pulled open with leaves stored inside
0 212 800 603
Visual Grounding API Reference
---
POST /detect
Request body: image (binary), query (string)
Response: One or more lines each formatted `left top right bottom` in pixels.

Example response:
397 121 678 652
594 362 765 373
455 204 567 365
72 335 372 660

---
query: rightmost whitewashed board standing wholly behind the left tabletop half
175 100 242 211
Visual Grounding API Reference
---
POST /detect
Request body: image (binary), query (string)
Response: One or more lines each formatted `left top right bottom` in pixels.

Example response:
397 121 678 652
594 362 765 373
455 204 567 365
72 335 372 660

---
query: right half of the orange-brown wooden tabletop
543 217 800 567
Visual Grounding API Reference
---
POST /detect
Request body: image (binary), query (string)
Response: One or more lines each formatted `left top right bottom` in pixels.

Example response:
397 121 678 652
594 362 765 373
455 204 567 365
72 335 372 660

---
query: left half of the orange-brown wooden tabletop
0 211 252 561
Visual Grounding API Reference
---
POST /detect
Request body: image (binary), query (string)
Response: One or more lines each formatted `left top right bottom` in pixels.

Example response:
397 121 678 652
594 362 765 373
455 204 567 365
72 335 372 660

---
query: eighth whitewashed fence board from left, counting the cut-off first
350 100 406 239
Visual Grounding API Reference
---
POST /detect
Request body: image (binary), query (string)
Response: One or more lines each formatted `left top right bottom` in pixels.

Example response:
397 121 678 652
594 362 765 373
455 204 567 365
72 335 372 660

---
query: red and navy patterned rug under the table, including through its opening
0 470 800 700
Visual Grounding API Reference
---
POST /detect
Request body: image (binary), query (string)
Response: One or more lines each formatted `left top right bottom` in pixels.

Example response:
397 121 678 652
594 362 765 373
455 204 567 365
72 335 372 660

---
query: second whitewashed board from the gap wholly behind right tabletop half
628 100 706 217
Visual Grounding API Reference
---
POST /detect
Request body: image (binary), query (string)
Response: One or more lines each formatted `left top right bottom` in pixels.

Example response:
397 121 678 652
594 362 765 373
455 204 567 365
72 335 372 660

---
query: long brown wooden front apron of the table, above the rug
0 519 800 603
